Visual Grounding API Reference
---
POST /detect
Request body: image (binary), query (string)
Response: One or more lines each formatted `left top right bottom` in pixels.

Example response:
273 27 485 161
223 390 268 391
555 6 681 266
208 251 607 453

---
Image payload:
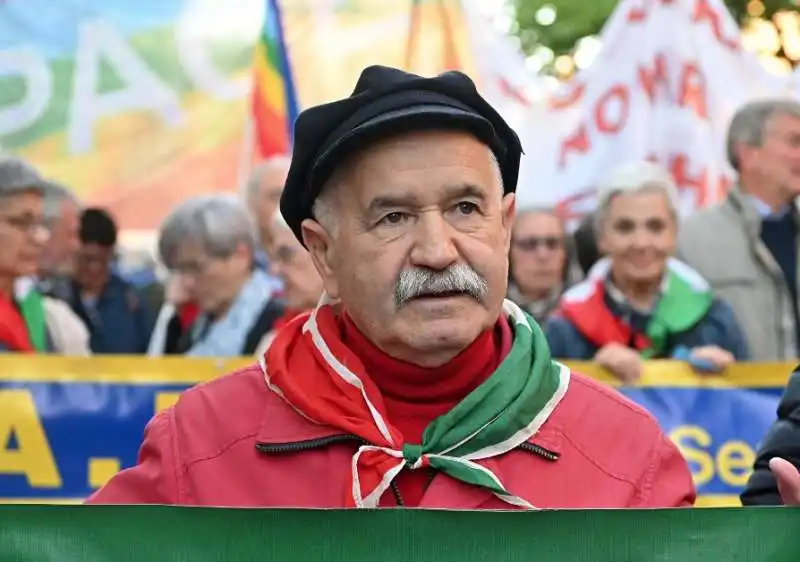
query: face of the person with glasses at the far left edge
0 191 48 278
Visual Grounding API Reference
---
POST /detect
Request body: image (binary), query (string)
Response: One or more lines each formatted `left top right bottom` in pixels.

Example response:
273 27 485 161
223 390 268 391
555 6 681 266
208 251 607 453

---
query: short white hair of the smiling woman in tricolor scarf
594 160 680 232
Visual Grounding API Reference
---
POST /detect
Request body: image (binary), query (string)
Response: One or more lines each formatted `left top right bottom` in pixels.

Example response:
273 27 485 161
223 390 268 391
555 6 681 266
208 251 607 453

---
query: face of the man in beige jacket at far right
747 114 800 202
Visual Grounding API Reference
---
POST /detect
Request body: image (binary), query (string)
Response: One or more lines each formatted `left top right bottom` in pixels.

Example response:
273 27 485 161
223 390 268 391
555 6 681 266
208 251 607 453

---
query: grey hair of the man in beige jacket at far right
725 99 800 172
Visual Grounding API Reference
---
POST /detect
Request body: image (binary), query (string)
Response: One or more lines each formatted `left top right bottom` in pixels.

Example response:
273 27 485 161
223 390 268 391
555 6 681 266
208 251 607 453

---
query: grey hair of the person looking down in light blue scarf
158 194 256 268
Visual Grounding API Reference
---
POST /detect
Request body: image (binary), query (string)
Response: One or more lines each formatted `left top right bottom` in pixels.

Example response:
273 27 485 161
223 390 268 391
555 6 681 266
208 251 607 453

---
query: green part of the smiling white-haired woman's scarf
641 269 714 359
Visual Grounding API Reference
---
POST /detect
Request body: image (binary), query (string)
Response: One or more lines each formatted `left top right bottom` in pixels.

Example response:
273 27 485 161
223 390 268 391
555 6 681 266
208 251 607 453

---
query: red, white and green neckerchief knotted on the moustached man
261 297 570 508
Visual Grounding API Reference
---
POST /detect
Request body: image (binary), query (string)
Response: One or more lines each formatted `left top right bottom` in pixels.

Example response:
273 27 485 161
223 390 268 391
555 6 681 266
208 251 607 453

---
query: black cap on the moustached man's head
280 66 522 243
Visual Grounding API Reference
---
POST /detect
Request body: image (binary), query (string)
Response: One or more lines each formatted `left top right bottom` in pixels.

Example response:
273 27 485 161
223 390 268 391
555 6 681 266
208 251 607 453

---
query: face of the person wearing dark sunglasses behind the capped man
511 212 567 297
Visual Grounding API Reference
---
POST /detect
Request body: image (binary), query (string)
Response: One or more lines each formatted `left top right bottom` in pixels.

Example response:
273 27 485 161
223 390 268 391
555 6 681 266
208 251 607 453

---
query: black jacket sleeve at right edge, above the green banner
742 366 800 505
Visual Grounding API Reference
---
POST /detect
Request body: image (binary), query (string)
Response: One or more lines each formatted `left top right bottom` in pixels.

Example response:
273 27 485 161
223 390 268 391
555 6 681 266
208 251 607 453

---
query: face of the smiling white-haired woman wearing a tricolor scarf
598 190 677 283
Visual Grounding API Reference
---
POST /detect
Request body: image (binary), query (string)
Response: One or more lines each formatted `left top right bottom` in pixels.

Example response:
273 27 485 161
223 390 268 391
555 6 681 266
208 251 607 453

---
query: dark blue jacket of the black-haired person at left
69 273 154 355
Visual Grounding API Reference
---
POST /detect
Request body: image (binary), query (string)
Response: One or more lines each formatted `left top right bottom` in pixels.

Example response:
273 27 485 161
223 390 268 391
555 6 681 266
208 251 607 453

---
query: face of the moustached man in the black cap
303 132 514 366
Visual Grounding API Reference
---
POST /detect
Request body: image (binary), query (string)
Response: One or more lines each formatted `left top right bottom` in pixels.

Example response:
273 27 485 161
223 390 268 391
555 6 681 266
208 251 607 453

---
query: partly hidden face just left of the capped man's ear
270 227 322 310
